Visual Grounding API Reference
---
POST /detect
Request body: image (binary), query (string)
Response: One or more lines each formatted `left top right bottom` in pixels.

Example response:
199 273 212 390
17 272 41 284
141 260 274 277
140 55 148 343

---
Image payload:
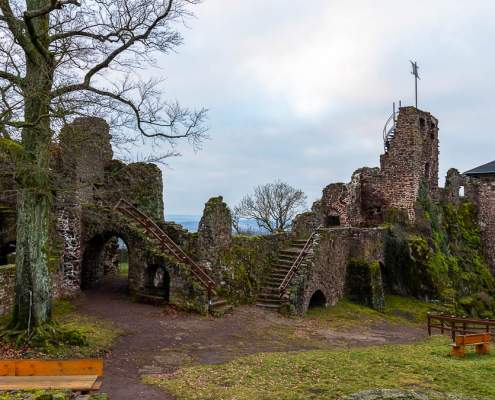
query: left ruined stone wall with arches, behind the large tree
0 118 198 315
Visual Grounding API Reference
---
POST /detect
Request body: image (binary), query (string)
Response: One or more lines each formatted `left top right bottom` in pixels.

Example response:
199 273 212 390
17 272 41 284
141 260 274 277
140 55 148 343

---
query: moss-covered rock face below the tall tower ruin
385 183 495 318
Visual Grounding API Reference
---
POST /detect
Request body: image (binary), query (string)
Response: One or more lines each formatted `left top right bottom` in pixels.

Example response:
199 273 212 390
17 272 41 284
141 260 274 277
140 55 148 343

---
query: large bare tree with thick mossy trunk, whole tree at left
0 0 206 338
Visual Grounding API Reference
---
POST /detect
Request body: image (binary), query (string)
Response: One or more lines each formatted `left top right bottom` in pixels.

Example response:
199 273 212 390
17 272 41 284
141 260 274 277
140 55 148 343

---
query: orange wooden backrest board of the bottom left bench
0 359 103 376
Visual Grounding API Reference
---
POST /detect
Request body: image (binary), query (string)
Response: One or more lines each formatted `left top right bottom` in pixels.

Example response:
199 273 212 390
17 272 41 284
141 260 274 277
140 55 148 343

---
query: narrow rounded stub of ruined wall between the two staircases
197 196 232 265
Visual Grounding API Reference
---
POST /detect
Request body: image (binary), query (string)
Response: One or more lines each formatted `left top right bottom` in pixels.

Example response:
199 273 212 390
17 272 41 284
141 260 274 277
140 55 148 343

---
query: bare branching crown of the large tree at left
0 0 206 155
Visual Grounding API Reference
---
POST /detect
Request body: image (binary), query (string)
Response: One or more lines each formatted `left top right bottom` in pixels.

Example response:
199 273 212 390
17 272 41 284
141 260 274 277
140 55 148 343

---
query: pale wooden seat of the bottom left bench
0 375 98 391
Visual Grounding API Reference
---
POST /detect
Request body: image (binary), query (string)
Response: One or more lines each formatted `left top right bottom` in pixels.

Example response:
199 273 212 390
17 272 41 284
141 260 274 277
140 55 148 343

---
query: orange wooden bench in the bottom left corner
0 359 103 393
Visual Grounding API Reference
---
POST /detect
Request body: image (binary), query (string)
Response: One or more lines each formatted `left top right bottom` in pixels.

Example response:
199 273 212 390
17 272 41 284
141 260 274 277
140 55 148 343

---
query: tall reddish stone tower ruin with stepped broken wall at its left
319 107 439 227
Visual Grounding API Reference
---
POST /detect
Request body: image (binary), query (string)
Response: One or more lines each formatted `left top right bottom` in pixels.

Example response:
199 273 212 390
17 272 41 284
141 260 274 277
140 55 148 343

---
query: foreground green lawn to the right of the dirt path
145 337 495 400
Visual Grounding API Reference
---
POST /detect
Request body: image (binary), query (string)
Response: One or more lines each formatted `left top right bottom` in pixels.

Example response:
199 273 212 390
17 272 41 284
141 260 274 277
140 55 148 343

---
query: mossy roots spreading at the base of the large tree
0 321 88 348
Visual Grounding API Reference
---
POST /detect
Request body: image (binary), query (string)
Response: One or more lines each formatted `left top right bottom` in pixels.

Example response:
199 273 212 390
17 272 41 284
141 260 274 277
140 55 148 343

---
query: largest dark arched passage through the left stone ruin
81 233 129 290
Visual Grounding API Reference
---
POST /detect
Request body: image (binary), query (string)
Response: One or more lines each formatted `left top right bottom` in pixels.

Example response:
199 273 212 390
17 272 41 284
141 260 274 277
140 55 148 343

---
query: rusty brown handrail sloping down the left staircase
114 199 216 294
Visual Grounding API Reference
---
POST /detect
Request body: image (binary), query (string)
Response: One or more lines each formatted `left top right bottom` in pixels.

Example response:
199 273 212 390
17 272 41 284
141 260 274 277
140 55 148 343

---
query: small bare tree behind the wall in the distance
234 181 306 233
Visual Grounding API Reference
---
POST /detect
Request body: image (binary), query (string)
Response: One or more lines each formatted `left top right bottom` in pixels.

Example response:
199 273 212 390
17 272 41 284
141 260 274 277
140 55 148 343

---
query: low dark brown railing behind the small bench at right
428 313 495 341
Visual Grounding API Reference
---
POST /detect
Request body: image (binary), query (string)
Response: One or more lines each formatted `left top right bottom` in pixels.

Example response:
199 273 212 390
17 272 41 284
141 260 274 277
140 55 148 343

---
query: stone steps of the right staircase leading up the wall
256 239 307 310
